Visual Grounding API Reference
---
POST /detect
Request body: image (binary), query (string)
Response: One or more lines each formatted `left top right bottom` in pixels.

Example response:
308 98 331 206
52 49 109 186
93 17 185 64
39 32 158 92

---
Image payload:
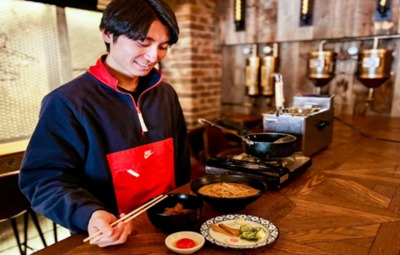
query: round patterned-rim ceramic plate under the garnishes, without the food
200 214 279 249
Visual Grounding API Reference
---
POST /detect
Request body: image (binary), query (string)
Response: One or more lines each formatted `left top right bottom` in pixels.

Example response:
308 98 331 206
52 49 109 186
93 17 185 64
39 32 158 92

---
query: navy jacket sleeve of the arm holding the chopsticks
20 91 105 233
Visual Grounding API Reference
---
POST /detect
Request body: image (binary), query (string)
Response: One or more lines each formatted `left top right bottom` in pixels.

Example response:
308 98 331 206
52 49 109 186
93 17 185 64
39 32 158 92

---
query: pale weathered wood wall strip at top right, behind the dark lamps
217 0 400 45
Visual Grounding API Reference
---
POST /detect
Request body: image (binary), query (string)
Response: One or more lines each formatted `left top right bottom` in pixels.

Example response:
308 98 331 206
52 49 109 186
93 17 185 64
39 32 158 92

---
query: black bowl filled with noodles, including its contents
190 174 267 212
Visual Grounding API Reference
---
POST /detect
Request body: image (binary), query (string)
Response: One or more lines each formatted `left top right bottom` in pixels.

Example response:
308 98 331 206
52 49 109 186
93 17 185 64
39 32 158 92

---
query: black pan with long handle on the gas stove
198 119 296 160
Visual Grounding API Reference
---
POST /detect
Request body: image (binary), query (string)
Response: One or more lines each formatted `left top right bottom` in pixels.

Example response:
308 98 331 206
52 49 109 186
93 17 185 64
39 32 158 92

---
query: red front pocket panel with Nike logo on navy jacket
107 138 175 213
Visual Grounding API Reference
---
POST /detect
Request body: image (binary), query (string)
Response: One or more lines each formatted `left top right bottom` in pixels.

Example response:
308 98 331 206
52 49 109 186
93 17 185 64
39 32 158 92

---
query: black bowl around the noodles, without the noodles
190 174 267 212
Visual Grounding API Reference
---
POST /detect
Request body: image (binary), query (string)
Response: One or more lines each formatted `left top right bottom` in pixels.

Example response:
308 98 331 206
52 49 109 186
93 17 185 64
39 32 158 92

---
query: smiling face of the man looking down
103 20 169 78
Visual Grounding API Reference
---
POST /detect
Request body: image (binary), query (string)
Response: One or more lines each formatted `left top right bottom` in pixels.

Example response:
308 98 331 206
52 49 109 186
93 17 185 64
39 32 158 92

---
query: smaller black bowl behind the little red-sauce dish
146 194 203 233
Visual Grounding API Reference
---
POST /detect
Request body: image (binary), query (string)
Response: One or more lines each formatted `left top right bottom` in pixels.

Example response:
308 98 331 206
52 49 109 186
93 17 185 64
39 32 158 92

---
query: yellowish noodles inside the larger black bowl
198 182 260 198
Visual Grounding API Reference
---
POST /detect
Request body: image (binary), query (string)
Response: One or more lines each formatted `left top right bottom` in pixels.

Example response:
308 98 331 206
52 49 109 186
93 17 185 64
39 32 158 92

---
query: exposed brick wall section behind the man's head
161 0 222 129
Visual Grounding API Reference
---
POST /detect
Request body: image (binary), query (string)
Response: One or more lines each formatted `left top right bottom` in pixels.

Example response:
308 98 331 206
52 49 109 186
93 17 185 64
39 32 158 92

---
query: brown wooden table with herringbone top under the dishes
32 117 400 255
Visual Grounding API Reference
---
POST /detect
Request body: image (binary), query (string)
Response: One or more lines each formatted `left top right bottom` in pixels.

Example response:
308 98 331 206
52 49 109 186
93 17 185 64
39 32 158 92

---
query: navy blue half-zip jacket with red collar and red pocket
20 56 190 233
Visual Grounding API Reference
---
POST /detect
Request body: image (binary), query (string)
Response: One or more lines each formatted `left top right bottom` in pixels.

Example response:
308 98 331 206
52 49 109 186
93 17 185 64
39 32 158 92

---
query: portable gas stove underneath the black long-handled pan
205 152 311 189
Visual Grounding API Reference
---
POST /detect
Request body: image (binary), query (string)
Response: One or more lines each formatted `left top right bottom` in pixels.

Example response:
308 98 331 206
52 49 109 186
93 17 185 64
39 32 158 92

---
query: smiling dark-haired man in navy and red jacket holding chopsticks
20 0 190 247
